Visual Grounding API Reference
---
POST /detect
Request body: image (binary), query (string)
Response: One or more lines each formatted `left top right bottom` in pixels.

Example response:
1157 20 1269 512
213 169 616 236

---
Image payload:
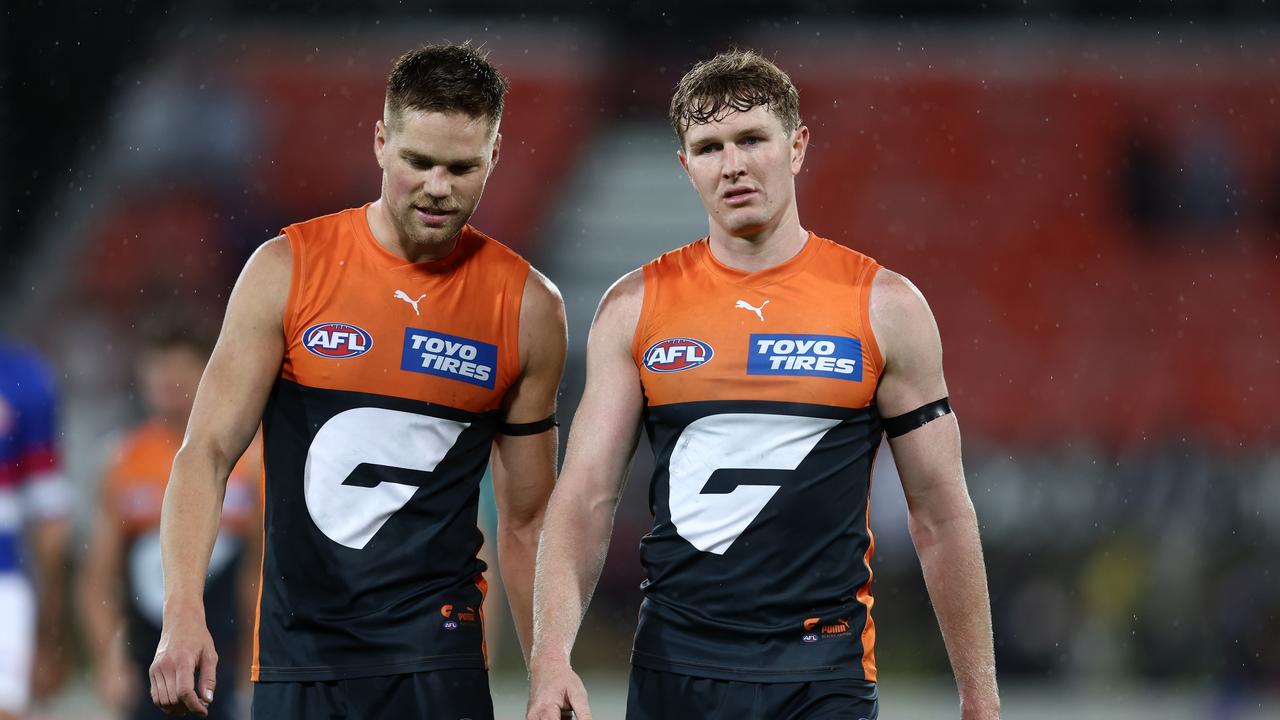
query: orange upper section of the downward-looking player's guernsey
280 205 529 411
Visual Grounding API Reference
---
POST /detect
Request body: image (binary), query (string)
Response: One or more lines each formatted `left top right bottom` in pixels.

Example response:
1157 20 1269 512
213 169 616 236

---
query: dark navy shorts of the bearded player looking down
252 670 494 720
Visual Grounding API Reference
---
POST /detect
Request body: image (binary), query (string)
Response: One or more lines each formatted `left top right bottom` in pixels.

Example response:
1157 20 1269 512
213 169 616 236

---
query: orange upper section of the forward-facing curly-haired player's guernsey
632 233 883 407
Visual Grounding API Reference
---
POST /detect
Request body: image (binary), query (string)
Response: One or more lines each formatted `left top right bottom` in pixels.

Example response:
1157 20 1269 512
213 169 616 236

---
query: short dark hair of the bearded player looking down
387 42 508 127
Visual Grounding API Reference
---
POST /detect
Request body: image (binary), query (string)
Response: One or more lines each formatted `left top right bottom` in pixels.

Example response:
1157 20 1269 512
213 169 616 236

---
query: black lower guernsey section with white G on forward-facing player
635 401 881 682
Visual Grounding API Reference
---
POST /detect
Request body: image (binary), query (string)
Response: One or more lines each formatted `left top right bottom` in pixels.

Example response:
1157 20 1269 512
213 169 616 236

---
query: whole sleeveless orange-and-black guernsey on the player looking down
253 206 529 680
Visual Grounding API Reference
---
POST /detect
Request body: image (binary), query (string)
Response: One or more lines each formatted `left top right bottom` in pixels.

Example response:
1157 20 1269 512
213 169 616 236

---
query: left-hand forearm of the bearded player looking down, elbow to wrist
160 446 230 616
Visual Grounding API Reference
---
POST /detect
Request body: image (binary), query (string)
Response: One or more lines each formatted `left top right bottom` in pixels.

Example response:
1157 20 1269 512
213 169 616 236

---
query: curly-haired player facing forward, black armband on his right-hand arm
529 51 1000 720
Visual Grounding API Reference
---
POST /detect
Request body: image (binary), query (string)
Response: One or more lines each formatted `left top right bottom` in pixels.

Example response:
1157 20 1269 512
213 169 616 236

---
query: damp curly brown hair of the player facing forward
671 50 800 143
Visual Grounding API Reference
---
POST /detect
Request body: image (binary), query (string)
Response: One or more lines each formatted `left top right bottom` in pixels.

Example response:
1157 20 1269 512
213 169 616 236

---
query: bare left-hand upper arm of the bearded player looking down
184 236 292 470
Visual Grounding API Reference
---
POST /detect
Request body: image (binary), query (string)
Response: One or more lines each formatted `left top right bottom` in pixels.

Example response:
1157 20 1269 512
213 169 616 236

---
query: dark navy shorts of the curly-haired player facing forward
627 666 879 720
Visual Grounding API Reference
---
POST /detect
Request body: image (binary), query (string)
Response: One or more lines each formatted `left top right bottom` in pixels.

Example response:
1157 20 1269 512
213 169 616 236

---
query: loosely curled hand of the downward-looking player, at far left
151 602 218 717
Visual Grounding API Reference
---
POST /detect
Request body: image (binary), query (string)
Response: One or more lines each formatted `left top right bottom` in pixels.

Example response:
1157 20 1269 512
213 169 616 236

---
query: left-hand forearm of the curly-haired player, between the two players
531 478 617 662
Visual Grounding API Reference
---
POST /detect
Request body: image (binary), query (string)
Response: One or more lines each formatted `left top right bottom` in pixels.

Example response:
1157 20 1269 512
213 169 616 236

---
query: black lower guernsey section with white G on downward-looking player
259 379 497 680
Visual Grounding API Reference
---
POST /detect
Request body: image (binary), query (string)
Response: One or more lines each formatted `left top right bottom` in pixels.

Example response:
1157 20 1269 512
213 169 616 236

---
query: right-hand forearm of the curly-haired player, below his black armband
910 498 1000 719
